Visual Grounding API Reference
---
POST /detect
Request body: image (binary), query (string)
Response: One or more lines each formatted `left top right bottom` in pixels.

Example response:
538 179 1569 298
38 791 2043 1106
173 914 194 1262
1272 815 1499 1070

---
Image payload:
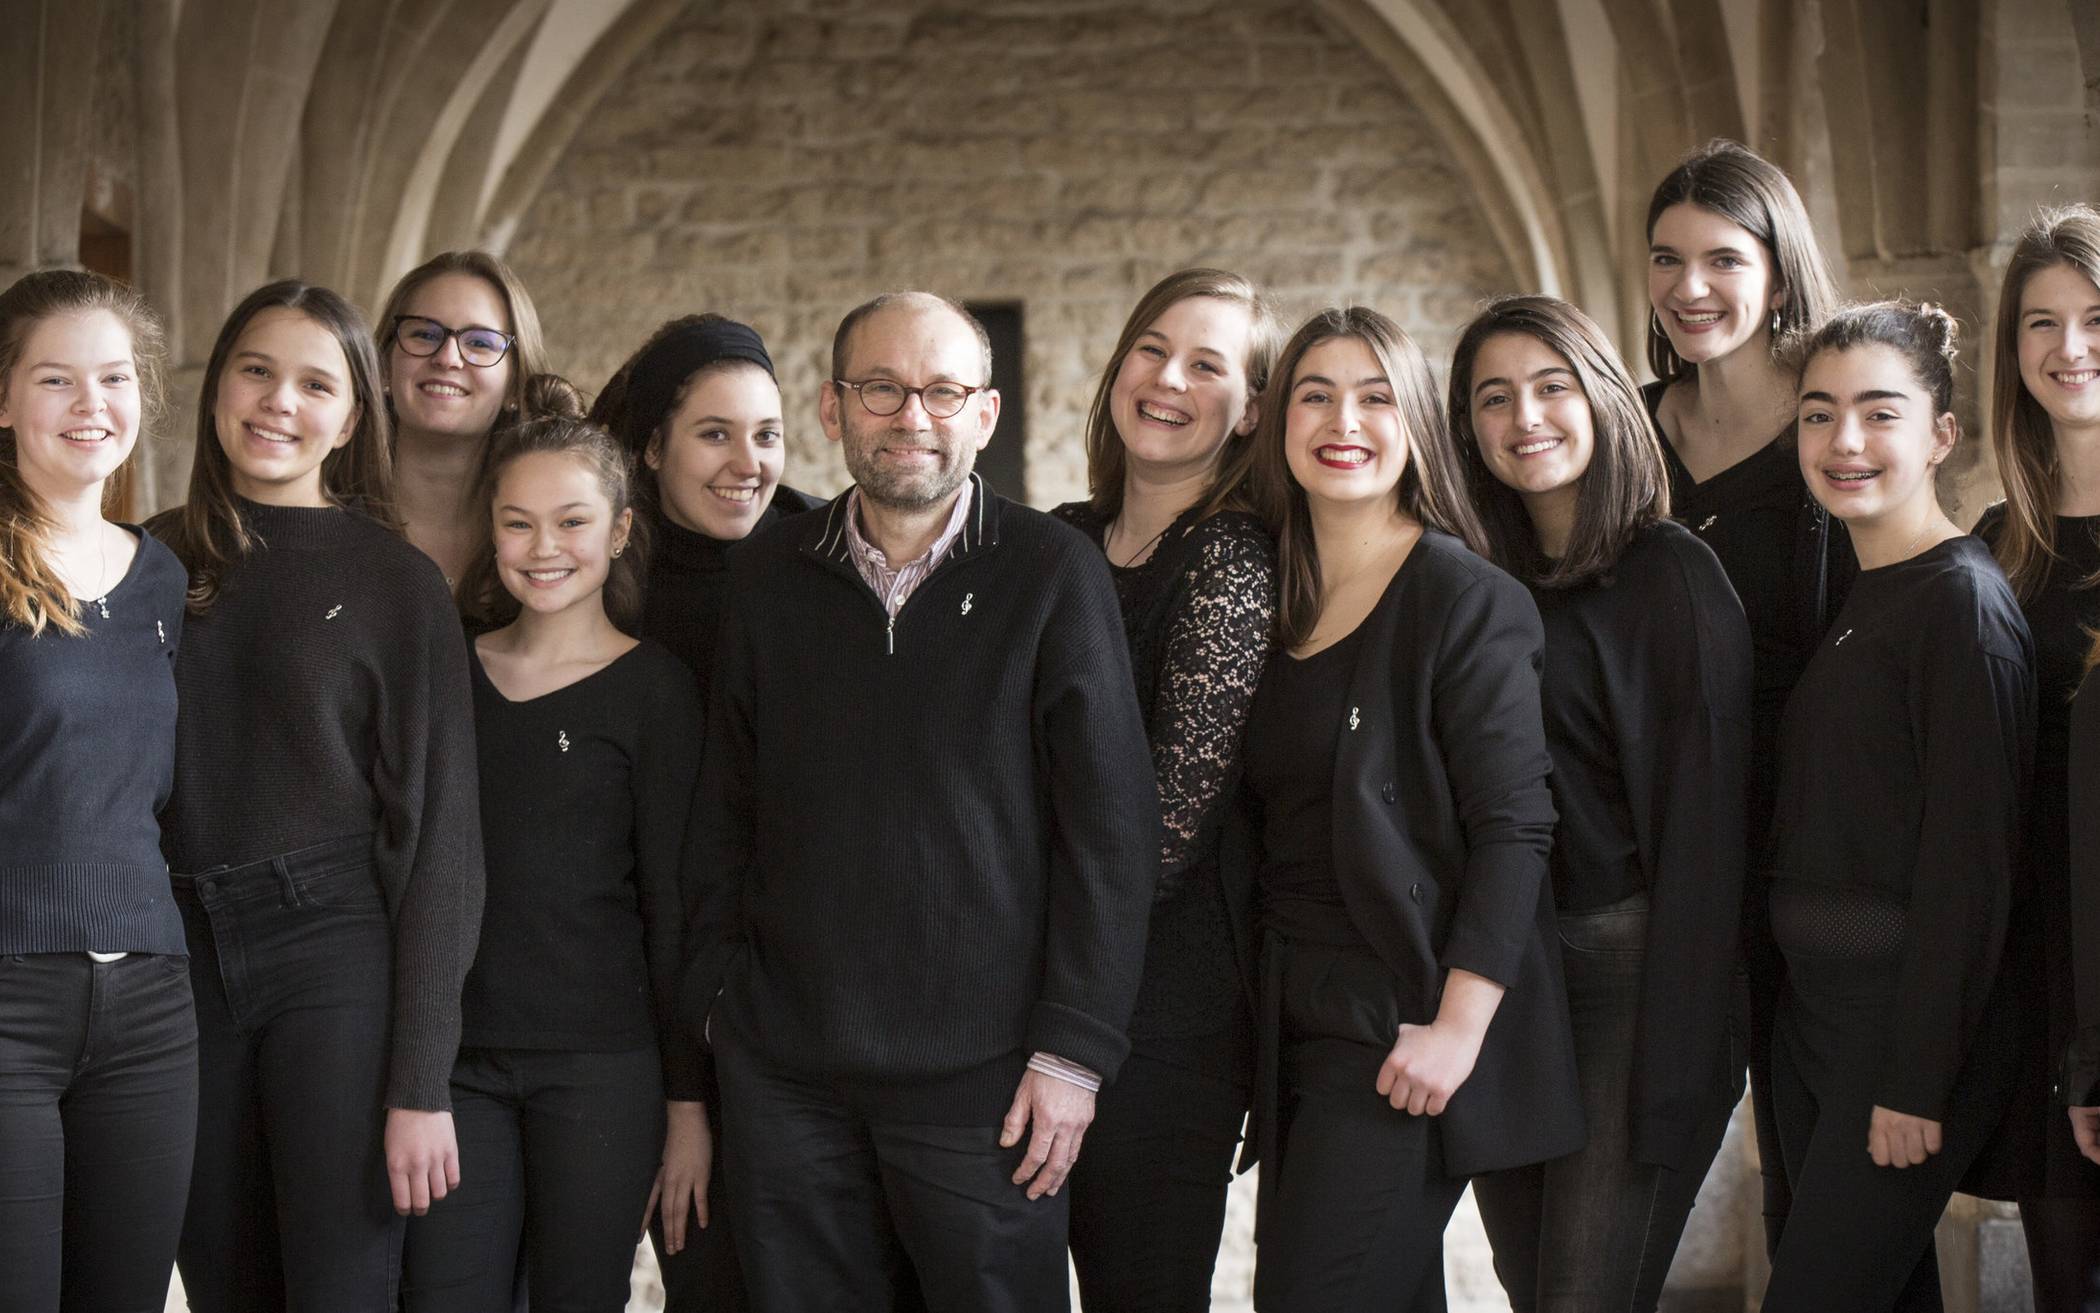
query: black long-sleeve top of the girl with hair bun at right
1772 538 2035 1120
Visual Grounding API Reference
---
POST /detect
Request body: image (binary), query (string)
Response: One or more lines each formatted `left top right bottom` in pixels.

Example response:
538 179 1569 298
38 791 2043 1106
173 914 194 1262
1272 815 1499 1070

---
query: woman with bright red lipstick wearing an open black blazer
1220 307 1583 1313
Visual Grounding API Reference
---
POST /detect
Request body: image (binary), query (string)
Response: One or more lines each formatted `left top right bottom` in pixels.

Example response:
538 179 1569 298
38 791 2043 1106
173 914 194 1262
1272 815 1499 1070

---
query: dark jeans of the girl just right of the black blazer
1472 897 1730 1313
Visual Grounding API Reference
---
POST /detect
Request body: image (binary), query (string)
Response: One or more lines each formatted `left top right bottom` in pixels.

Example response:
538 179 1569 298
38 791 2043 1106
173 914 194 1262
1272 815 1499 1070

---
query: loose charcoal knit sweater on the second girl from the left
149 500 481 1109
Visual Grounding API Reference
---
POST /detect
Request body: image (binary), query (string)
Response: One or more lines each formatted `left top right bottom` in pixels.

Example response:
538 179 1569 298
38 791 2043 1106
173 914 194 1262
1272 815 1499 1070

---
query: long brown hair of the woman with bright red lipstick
1247 305 1487 647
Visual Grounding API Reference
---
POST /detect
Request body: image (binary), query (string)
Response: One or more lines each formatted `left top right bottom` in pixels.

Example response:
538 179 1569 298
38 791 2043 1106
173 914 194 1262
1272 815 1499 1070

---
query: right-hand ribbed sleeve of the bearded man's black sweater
1025 550 1159 1082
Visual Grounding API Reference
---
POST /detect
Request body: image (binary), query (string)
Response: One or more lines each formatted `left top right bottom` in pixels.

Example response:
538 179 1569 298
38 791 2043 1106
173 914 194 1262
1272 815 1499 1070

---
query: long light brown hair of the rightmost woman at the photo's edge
1991 206 2100 601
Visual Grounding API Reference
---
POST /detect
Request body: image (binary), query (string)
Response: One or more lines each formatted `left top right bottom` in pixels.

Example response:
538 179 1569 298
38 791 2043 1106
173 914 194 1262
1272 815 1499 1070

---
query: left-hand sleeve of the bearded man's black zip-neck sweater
674 567 758 1084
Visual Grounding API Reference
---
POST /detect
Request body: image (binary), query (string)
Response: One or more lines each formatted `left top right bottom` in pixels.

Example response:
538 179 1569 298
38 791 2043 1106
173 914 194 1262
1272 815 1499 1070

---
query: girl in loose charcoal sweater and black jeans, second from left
151 279 481 1313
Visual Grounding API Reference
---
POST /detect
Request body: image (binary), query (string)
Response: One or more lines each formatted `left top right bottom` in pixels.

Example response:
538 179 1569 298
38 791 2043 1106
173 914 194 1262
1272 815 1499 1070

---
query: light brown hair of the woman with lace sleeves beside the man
1086 269 1283 519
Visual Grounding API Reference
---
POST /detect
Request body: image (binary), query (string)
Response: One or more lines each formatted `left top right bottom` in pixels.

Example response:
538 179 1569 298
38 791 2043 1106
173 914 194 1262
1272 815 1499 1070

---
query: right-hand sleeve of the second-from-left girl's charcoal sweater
372 561 483 1111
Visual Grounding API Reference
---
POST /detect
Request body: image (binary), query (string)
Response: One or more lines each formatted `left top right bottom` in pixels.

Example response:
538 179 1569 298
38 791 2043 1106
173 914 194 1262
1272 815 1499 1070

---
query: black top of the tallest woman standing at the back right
1640 382 1859 848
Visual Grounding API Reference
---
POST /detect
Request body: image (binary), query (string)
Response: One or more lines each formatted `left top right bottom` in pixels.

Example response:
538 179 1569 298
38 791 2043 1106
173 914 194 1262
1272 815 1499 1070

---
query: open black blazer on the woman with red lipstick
1220 532 1588 1176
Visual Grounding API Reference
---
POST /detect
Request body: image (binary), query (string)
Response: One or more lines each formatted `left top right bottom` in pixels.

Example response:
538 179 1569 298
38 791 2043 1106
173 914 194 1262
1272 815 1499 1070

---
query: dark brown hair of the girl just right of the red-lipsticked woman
1449 296 1670 588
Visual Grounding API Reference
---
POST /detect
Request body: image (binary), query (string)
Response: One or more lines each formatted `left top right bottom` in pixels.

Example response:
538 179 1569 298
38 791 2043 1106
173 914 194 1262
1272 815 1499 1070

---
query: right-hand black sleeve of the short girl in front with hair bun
632 660 701 1099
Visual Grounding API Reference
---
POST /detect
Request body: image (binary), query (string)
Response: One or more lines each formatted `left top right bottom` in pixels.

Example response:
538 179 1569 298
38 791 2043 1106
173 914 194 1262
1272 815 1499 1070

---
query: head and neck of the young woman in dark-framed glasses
378 250 546 580
